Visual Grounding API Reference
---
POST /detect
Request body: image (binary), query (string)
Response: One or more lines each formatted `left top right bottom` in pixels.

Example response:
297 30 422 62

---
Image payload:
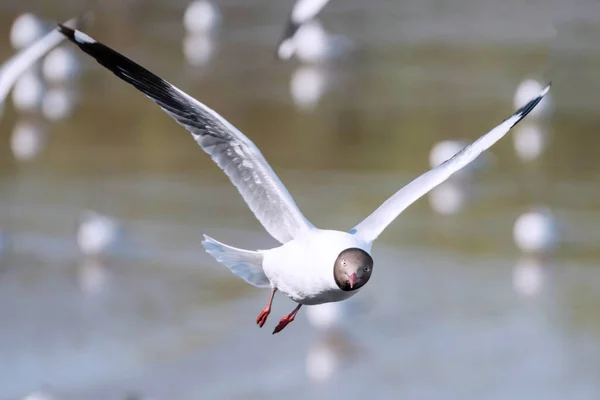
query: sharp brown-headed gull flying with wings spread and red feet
60 26 550 334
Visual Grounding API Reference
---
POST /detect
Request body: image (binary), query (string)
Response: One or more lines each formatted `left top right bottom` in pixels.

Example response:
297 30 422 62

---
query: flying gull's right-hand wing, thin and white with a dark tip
350 84 550 242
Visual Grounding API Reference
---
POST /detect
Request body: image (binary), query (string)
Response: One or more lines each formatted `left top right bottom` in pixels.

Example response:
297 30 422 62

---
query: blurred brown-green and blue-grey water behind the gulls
0 0 600 400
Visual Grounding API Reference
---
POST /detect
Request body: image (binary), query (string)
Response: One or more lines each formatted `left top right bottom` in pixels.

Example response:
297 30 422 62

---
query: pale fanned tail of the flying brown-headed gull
202 235 271 287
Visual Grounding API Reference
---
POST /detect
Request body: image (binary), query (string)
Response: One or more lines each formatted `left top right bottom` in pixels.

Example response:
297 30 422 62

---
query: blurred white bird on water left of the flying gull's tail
77 210 121 257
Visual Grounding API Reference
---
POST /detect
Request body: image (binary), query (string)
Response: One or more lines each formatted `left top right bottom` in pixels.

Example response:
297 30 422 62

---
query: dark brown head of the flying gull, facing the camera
333 247 373 292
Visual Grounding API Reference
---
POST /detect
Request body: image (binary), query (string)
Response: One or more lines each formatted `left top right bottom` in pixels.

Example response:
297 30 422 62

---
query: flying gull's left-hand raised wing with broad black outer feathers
59 25 314 243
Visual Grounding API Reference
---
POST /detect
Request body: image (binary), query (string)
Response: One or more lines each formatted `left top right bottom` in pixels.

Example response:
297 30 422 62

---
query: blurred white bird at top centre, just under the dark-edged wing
277 20 353 63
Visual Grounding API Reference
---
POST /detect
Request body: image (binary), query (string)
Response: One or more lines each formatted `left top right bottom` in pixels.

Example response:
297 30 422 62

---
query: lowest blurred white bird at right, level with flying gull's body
513 207 559 255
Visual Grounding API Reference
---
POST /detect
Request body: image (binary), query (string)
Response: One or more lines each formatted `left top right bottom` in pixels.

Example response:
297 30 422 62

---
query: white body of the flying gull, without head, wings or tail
263 230 370 305
